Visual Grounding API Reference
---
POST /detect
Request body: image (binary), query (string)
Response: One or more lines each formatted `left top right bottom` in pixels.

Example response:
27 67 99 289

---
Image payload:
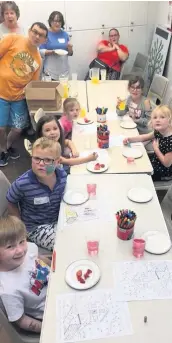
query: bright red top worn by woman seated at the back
97 40 128 71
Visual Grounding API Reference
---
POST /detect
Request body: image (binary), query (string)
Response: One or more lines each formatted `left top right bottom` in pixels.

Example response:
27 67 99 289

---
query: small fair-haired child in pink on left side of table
59 98 80 138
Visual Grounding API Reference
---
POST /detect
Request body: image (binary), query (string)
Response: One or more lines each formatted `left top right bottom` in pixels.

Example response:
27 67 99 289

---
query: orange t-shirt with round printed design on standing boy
0 34 42 101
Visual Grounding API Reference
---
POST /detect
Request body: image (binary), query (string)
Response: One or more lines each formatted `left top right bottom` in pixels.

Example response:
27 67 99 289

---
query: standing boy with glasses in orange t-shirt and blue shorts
0 22 48 167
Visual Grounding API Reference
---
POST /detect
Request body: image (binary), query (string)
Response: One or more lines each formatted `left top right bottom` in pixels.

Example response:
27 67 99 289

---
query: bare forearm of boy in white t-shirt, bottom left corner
15 314 42 332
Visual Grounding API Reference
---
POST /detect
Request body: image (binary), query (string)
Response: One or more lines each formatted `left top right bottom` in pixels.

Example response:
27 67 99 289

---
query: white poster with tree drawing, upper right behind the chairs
146 26 171 91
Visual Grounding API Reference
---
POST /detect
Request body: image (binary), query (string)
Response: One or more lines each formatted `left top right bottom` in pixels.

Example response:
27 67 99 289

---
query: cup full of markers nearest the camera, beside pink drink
116 209 137 241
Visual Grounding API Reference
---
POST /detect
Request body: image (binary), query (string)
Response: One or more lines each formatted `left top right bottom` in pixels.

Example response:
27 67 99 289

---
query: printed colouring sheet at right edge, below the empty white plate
113 260 172 301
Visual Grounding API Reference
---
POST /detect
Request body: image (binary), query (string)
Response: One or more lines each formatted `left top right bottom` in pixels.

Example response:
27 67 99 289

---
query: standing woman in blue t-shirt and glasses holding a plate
40 11 73 80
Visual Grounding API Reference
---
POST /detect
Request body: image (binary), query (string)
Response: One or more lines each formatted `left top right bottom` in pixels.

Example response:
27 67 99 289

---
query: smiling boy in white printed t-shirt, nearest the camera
0 216 50 332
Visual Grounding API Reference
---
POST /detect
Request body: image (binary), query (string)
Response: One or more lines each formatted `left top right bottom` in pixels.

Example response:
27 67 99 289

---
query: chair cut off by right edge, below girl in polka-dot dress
161 185 172 240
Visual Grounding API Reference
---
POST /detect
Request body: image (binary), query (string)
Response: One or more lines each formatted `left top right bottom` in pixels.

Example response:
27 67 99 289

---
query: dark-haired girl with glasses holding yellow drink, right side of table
116 76 152 134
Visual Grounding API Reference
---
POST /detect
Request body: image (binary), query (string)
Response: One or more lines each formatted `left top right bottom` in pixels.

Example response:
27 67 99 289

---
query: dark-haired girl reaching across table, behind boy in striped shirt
25 115 98 169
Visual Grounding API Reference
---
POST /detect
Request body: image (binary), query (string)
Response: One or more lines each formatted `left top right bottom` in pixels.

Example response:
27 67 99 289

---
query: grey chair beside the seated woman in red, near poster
121 52 148 80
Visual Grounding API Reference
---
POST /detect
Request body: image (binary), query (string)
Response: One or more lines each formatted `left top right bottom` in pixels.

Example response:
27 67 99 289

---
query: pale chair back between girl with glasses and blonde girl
147 74 169 105
